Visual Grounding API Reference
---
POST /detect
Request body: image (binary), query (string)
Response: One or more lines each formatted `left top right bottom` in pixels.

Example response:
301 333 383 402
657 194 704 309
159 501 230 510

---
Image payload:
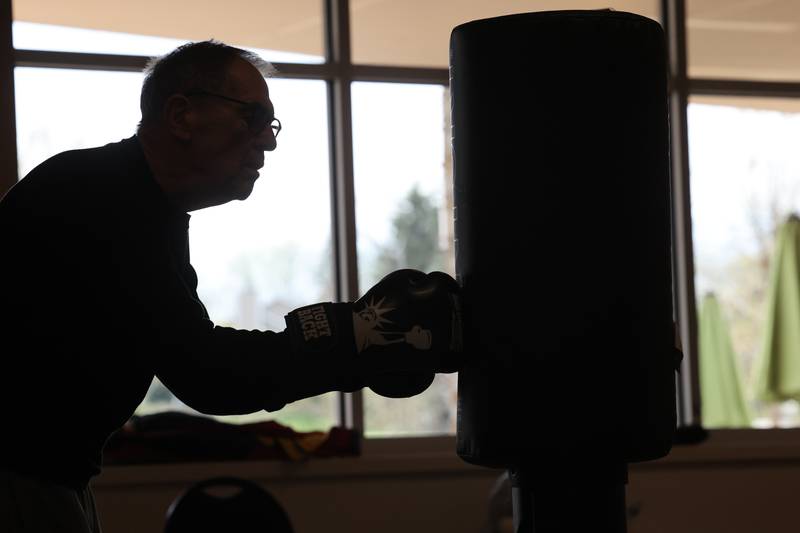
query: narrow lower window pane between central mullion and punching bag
352 83 456 437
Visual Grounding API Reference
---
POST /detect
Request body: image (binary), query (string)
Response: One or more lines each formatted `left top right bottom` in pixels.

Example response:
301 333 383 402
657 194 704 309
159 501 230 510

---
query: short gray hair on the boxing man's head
139 39 276 128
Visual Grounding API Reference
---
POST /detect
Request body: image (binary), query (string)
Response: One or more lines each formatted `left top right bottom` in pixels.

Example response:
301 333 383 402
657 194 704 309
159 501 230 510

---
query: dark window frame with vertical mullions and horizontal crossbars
0 0 800 454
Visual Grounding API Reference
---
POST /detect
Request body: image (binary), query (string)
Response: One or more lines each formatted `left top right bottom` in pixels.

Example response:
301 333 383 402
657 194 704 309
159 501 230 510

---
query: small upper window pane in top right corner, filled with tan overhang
686 0 800 80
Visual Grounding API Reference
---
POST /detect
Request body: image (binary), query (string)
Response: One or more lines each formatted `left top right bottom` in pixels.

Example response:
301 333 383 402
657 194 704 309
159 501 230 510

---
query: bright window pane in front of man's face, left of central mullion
191 79 339 431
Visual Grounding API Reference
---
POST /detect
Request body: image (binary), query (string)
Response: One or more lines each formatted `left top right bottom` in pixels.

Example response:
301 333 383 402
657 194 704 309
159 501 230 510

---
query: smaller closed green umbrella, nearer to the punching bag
698 293 751 427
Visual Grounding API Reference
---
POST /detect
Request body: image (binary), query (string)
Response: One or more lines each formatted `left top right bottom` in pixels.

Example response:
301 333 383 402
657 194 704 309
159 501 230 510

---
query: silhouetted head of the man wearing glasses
139 41 280 210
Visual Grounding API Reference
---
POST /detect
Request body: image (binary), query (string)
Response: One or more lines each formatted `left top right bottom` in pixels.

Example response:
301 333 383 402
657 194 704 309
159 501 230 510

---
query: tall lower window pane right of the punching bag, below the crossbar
689 97 800 427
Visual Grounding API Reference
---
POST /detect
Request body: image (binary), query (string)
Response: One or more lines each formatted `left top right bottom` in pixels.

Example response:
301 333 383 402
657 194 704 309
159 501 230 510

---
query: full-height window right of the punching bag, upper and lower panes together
676 0 800 428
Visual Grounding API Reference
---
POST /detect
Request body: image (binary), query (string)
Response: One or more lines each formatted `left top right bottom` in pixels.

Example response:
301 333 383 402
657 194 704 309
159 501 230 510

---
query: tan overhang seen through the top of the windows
13 0 800 81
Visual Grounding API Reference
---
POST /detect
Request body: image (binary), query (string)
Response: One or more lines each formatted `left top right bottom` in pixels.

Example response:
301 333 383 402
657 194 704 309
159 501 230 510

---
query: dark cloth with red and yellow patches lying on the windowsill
103 411 360 465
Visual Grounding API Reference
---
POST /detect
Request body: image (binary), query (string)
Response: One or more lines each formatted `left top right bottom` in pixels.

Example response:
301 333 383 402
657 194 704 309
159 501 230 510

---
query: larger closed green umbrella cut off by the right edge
755 215 800 402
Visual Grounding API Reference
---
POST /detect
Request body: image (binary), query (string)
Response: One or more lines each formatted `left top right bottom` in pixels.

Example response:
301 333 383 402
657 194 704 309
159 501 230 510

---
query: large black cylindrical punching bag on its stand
450 10 678 532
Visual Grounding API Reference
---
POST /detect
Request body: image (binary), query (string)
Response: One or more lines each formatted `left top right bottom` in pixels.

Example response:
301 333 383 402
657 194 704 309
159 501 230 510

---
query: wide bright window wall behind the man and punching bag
6 0 800 454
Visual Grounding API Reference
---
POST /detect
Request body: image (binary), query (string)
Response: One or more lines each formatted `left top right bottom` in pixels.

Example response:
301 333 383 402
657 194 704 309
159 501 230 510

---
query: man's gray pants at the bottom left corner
0 470 101 533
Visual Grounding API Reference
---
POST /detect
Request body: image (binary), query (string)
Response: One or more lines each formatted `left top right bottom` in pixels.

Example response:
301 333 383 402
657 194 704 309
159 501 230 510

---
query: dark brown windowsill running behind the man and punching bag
93 429 800 488
